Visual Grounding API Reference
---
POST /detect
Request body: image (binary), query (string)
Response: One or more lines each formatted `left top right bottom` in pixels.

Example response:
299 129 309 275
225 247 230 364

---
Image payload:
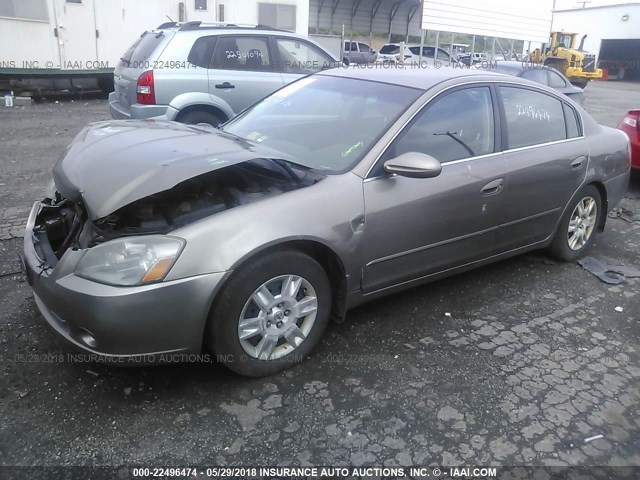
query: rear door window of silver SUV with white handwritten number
212 36 271 70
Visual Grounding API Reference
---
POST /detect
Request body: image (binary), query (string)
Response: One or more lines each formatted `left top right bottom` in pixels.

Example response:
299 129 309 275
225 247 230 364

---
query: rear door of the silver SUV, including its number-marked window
208 35 284 113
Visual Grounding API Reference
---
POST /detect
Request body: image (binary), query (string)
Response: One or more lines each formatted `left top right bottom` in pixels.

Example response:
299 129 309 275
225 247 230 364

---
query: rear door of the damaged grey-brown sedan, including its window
497 85 589 250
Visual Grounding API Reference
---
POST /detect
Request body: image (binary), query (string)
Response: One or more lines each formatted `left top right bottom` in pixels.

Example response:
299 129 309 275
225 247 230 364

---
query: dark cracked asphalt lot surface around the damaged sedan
0 82 640 465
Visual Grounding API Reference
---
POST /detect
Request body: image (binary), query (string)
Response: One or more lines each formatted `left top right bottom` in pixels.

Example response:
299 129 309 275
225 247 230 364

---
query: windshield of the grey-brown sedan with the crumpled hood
223 75 422 174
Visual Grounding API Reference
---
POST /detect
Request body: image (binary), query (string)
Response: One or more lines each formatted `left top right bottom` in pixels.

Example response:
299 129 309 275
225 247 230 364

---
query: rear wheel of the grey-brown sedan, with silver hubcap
549 185 603 262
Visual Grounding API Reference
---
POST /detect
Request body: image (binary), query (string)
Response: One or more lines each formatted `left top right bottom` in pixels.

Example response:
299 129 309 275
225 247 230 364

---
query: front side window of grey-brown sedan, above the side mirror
383 87 494 170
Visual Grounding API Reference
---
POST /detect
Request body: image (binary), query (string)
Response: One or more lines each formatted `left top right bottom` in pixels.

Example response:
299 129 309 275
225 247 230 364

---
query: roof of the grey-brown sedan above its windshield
318 65 504 90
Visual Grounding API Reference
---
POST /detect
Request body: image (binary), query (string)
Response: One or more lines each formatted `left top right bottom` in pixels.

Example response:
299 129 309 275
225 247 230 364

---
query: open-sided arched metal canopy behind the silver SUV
309 0 421 36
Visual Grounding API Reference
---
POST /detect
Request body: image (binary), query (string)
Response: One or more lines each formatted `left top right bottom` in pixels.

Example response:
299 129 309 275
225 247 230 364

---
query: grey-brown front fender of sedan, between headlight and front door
167 173 364 280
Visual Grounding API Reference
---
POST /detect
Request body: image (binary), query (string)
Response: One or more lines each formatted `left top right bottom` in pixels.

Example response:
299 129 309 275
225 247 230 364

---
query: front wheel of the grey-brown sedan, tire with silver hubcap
205 250 331 377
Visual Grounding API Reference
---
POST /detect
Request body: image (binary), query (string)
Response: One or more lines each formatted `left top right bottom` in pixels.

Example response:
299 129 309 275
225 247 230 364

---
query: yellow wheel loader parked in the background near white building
530 32 602 88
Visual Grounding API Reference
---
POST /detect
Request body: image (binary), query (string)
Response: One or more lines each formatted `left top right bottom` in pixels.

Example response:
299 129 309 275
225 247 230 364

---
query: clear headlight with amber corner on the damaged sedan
75 235 185 286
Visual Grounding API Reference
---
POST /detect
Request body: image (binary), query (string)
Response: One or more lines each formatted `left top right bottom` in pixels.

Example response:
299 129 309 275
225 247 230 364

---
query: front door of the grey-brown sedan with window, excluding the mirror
362 84 505 293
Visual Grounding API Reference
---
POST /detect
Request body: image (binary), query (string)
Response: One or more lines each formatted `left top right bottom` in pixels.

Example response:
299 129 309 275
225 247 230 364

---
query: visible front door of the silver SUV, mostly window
272 37 336 85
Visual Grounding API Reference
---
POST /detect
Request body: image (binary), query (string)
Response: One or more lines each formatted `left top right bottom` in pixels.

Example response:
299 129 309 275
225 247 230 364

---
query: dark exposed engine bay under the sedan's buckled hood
34 159 323 262
